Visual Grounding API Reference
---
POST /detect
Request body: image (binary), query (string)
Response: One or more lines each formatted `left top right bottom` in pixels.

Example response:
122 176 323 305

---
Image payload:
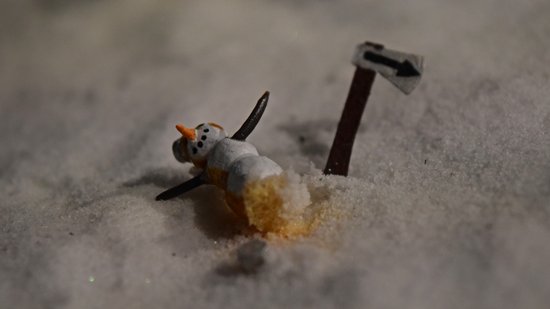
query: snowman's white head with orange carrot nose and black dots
172 122 227 168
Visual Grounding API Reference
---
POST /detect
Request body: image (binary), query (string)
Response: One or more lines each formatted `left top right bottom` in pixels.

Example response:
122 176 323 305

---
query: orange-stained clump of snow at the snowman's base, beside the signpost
243 170 354 239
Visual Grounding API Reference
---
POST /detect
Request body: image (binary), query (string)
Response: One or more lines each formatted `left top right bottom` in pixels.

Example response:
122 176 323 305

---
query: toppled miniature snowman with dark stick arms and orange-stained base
156 92 312 236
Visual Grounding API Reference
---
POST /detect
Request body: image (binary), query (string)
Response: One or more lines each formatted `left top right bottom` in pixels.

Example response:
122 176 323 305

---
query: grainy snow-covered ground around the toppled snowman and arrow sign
0 0 550 308
